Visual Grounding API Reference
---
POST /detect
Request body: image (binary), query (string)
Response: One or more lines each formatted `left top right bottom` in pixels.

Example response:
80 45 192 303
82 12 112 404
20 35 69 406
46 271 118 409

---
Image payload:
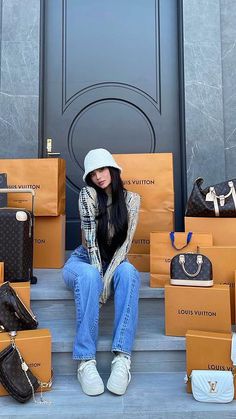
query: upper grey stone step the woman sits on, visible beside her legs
31 269 164 300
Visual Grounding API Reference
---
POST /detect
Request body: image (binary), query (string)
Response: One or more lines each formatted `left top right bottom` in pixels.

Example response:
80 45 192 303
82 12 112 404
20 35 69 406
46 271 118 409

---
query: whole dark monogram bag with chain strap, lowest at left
0 332 52 404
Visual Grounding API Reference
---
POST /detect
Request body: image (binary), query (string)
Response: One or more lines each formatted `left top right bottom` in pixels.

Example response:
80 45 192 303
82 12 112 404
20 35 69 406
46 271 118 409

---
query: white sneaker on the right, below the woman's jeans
107 354 131 396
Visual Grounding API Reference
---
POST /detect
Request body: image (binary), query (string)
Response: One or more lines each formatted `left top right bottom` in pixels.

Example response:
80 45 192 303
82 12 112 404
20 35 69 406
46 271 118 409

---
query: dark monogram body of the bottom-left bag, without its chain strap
0 345 39 403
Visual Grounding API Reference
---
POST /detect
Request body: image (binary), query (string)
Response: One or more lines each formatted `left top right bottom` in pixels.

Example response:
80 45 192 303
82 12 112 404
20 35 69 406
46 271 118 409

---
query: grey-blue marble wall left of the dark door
0 0 40 158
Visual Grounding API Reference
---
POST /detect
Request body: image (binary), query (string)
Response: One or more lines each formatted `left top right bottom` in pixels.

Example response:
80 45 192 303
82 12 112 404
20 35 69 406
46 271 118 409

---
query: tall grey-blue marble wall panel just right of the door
183 0 225 191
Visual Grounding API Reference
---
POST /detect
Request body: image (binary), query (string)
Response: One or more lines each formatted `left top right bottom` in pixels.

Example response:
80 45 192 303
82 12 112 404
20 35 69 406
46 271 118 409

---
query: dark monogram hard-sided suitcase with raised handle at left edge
0 188 36 283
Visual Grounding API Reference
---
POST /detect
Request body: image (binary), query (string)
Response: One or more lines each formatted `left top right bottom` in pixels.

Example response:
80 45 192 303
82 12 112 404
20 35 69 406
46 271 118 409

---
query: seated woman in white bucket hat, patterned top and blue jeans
63 148 140 396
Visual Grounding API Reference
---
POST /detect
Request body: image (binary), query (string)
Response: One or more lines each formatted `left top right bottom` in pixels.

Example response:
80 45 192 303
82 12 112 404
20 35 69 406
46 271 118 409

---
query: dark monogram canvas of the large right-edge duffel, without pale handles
185 178 236 217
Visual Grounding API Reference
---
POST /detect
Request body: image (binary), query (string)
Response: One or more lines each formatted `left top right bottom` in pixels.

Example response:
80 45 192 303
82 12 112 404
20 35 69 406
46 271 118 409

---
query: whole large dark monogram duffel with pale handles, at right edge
185 178 236 217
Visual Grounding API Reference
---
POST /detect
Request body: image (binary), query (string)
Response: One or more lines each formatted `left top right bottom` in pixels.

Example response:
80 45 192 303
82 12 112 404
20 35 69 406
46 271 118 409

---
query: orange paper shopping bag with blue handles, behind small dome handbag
150 231 213 288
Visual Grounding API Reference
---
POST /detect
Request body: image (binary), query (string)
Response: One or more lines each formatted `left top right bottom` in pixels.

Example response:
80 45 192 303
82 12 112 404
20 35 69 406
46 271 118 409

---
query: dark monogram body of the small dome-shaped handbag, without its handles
170 253 212 282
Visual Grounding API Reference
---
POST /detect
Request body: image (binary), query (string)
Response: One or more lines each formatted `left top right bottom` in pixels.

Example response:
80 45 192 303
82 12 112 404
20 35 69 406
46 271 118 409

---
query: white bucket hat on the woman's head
83 148 122 181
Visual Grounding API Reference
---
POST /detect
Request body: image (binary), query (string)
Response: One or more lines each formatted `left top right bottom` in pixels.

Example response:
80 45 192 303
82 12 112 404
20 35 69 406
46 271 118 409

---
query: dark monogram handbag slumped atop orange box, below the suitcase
0 282 38 332
